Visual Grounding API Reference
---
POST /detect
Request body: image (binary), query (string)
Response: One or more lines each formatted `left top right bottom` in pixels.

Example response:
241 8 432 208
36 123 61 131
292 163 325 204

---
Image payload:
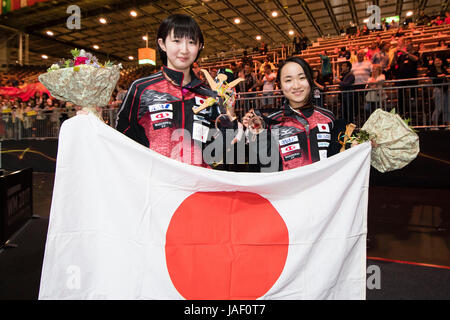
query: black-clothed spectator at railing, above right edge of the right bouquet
392 44 419 115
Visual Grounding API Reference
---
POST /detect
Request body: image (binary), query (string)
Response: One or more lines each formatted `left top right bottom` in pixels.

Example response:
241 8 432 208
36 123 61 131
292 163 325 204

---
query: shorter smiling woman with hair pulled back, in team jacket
242 57 345 171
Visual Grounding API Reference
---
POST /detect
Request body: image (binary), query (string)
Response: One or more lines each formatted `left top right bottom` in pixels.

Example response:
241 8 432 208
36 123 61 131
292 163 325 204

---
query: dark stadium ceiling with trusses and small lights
0 0 449 64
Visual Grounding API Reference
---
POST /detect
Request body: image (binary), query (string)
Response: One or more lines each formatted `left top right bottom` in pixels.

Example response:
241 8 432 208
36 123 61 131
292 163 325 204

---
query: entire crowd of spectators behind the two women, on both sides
0 11 450 132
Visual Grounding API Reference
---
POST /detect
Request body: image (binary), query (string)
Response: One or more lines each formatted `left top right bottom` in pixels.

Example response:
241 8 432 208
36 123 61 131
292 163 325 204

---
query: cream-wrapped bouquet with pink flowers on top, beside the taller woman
39 49 122 118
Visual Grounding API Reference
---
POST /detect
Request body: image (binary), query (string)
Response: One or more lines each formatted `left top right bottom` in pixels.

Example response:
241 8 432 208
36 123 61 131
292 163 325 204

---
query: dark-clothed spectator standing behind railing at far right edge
427 54 450 125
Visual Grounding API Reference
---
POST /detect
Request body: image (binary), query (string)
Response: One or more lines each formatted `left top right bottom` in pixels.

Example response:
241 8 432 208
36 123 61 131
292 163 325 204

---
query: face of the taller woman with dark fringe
158 30 200 72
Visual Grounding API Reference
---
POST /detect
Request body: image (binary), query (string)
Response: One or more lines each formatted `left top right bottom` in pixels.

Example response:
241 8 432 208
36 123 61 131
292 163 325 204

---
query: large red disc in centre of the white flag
165 192 289 300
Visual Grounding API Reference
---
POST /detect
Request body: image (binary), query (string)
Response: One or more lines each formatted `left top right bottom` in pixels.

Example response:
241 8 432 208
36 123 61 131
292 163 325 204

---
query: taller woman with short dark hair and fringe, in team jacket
116 14 237 167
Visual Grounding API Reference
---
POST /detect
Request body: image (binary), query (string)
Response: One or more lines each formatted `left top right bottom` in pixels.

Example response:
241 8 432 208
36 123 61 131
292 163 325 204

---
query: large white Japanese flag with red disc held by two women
39 115 371 300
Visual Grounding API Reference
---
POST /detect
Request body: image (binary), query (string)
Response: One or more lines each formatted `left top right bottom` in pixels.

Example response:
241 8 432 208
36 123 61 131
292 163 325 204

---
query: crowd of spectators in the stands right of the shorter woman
315 11 450 124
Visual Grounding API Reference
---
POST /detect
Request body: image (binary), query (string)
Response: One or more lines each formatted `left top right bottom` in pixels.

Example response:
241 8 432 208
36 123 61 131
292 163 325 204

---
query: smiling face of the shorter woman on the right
280 62 311 109
